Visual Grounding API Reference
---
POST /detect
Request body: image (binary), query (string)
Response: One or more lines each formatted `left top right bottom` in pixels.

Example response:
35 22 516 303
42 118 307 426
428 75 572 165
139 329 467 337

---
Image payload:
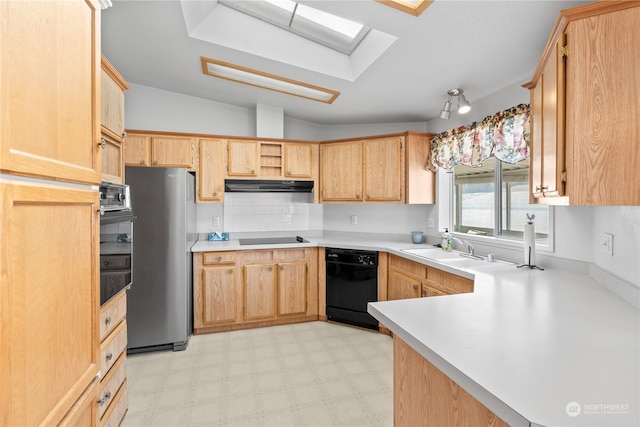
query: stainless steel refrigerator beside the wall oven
125 167 196 353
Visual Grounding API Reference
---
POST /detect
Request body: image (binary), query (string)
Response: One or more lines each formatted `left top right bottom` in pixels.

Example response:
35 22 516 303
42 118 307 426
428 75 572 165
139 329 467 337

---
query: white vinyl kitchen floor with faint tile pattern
117 322 393 427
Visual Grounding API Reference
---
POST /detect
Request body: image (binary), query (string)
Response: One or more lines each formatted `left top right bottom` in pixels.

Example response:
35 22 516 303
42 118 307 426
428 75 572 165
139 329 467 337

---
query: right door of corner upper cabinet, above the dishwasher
364 137 404 202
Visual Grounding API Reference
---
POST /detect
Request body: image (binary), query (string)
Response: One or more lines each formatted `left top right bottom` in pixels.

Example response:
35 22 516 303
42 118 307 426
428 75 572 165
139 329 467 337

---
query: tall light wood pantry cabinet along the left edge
0 0 101 426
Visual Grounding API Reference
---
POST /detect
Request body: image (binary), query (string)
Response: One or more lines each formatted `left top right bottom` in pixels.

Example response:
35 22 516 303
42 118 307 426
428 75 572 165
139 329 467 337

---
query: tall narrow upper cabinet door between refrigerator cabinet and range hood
198 139 224 202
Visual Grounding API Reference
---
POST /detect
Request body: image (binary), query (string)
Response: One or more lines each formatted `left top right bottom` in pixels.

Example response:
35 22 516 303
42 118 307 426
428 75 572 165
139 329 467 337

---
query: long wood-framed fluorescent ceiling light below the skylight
200 56 340 104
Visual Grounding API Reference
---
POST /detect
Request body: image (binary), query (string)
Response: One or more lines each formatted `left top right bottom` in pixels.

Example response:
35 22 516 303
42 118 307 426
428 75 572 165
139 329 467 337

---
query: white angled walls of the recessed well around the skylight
181 0 397 82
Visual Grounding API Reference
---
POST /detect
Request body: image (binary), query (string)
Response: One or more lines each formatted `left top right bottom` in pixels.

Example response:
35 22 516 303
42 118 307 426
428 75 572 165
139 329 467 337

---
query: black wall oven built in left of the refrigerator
100 182 135 306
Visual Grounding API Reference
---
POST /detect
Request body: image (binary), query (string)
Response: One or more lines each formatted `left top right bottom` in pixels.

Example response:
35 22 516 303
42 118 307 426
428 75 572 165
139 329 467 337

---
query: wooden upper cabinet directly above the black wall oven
100 56 129 184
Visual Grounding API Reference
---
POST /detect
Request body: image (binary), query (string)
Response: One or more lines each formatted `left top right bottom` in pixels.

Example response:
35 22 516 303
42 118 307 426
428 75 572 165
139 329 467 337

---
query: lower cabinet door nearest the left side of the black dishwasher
278 261 307 316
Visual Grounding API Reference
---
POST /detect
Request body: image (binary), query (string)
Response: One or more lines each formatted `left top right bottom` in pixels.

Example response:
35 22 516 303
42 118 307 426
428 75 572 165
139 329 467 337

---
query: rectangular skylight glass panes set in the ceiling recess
219 0 370 55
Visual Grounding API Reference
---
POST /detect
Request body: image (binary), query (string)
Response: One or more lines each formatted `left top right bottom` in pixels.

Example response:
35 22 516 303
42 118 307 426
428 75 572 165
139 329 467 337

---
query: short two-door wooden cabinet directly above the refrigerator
124 131 195 169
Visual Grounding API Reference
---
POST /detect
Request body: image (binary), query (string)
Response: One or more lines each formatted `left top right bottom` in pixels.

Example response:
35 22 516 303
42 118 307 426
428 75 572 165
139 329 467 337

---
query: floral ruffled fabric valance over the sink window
425 104 531 171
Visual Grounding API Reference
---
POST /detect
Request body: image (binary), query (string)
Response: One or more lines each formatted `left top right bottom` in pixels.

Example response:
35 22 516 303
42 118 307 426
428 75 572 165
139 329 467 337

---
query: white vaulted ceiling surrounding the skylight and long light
102 0 586 124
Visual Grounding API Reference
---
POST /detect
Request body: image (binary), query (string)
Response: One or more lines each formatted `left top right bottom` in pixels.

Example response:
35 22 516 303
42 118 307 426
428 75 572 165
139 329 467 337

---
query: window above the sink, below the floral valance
452 157 549 240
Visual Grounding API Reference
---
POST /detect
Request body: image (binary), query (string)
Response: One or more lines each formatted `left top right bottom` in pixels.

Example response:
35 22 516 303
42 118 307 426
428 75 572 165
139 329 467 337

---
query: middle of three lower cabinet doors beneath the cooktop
243 264 277 320
